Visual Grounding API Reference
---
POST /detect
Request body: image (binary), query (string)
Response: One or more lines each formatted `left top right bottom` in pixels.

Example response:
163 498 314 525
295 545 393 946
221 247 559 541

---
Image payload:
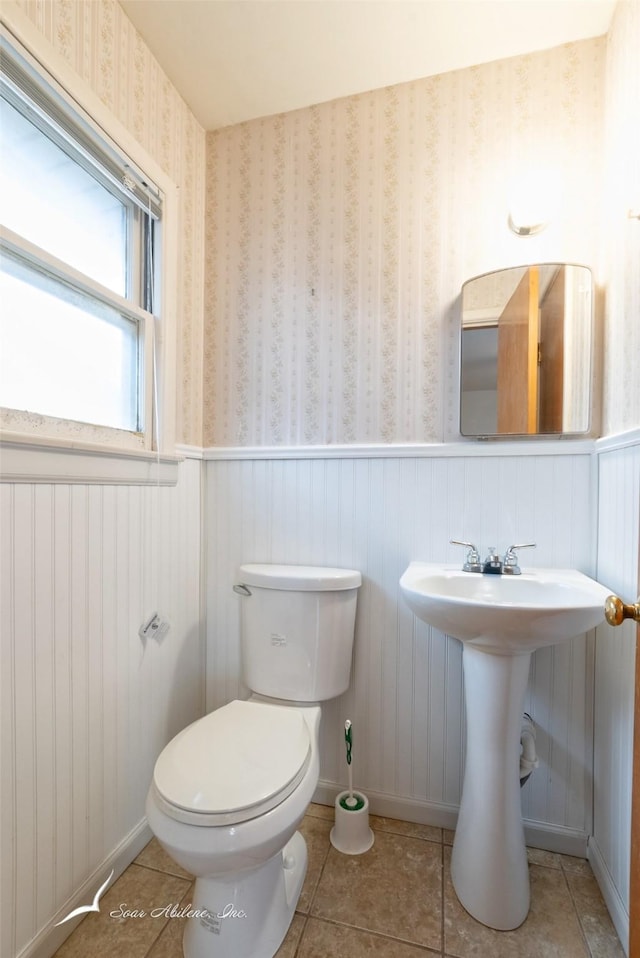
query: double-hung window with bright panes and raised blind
0 36 162 448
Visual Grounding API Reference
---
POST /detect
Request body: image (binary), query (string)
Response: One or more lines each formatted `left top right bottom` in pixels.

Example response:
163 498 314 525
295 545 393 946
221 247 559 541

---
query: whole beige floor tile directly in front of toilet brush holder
311 832 442 949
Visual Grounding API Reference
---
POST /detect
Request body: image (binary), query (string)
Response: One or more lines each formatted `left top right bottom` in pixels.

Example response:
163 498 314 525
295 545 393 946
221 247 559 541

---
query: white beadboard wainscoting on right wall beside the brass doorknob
589 430 640 943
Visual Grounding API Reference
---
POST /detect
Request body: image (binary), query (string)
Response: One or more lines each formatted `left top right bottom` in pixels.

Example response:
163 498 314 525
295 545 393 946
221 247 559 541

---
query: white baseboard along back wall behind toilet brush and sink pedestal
313 781 588 858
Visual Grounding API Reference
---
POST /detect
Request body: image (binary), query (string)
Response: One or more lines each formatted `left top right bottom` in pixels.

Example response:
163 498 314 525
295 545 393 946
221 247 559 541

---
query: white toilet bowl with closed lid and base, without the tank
147 699 320 958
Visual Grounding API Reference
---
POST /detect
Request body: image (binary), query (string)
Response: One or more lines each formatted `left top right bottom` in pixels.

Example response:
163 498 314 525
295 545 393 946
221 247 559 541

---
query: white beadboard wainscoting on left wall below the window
0 460 204 958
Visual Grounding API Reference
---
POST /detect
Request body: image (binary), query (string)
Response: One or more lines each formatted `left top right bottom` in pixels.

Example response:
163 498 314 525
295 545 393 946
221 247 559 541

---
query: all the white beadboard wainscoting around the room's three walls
0 432 640 958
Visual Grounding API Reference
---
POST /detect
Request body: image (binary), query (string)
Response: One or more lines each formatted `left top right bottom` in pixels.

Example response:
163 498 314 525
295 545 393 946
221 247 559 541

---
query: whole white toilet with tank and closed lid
146 564 362 958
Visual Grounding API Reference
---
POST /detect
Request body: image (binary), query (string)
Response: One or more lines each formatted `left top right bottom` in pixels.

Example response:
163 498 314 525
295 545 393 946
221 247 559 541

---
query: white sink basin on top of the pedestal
400 562 610 653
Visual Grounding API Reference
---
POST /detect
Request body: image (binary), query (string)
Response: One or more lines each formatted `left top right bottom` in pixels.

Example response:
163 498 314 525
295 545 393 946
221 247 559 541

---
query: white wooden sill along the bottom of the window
0 433 183 486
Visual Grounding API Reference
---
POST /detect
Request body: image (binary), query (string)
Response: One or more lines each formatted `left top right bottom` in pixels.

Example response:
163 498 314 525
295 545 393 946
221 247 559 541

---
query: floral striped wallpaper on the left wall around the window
17 0 205 445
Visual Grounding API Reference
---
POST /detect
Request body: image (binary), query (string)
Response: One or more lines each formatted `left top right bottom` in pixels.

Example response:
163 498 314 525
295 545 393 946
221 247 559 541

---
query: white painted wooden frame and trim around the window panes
0 7 180 483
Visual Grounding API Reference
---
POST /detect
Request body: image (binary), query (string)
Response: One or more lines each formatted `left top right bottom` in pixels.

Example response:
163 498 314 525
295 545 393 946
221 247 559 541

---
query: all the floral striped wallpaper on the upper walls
6 0 640 446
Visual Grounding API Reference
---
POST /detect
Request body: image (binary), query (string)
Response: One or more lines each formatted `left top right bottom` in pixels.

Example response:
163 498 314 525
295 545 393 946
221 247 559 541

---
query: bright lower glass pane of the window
0 255 144 434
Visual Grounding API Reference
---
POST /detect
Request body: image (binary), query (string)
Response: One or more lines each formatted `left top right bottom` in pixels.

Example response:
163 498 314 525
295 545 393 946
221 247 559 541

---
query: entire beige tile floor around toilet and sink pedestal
55 805 624 958
